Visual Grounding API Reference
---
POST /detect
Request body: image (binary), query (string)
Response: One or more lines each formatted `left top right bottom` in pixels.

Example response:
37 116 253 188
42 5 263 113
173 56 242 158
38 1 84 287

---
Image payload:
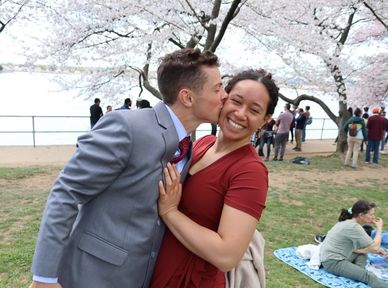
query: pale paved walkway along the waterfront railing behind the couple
0 140 336 167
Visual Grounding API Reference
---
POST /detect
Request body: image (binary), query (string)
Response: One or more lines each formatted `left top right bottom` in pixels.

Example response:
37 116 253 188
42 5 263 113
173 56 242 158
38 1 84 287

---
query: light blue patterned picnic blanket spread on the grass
274 247 388 288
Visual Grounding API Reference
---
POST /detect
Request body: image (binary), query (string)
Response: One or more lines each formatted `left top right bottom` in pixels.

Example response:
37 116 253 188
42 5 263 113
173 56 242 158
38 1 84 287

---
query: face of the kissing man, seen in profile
191 66 226 123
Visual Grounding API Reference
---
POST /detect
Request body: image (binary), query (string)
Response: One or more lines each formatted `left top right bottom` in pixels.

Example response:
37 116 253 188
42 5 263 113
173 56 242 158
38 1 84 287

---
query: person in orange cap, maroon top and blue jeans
365 107 385 165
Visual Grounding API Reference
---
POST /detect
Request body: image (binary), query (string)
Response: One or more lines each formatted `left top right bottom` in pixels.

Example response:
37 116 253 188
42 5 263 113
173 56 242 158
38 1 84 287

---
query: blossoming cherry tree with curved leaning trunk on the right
238 0 388 151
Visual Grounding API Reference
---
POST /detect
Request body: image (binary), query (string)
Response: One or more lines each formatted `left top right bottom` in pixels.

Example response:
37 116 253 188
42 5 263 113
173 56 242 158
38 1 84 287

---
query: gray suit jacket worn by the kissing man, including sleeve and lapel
32 103 190 288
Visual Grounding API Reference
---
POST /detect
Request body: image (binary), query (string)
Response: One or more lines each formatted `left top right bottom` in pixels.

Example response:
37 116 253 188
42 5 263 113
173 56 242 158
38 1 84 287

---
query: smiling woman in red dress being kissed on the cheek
151 69 278 288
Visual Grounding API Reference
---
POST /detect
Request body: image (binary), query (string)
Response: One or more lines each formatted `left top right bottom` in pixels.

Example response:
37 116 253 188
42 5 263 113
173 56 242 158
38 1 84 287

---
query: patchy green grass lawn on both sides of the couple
0 155 388 288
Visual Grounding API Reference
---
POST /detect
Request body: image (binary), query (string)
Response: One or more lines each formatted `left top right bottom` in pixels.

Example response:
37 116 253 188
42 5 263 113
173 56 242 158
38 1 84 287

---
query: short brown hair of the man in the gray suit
158 48 219 105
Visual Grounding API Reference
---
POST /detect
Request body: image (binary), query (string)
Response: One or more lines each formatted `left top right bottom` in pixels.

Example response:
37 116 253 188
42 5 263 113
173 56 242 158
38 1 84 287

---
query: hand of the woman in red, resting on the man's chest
158 163 182 217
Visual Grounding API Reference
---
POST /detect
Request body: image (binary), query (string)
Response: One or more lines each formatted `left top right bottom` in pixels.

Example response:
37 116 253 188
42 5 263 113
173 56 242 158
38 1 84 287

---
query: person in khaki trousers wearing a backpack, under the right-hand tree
343 108 367 168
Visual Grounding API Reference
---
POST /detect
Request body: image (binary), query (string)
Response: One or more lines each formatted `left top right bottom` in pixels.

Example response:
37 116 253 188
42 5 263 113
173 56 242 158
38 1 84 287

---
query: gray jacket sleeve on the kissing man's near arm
32 112 132 277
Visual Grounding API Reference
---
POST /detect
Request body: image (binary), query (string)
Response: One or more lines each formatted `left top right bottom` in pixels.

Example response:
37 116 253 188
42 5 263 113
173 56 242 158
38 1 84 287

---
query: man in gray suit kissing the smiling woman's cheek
30 49 225 288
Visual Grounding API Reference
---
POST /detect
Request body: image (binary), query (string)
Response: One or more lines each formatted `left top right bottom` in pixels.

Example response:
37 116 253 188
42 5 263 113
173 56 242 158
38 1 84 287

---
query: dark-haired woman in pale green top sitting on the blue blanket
320 200 388 288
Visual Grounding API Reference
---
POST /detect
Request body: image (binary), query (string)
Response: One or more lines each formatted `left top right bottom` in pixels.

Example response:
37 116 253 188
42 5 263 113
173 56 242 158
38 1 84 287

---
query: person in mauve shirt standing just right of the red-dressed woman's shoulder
272 103 294 161
